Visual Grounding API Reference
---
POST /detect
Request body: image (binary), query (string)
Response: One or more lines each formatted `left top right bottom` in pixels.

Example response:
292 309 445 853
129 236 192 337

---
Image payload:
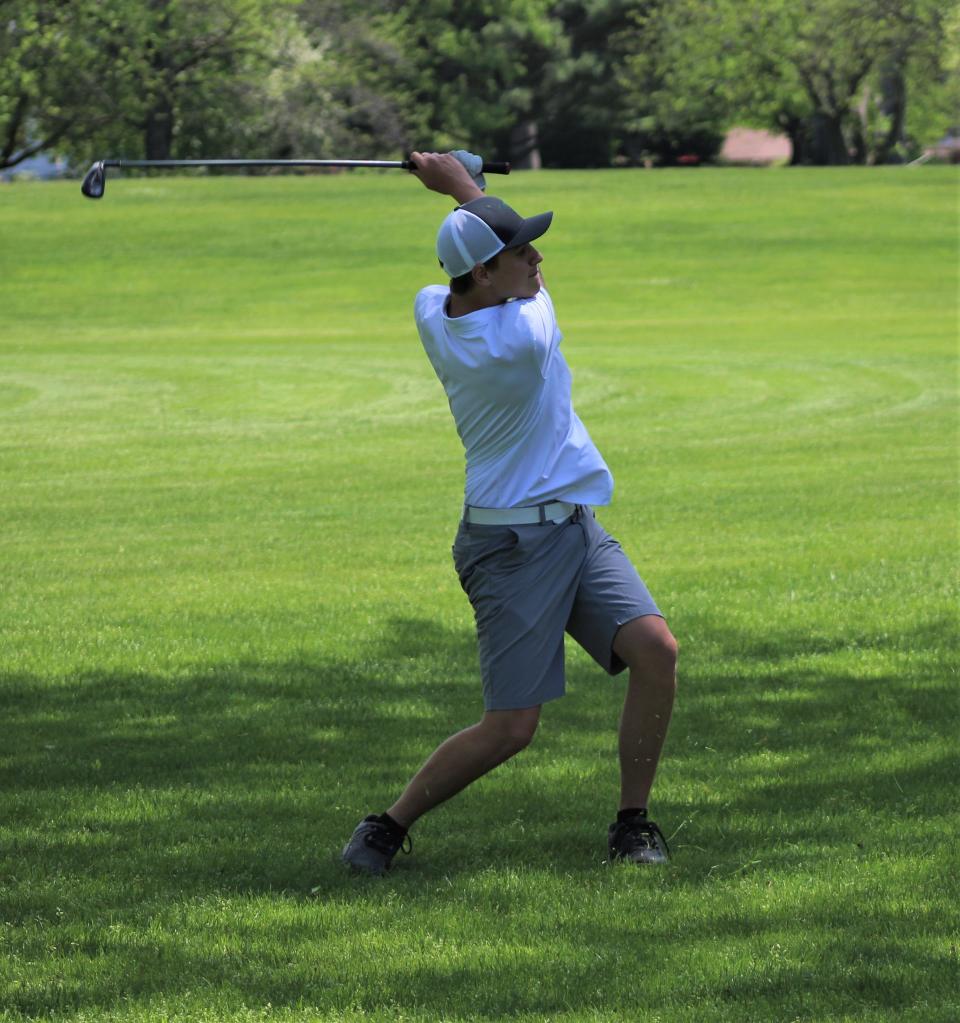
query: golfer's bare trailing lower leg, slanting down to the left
387 707 540 829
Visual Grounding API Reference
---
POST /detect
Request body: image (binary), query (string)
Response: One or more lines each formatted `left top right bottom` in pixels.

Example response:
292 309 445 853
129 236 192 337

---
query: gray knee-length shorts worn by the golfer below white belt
452 504 662 710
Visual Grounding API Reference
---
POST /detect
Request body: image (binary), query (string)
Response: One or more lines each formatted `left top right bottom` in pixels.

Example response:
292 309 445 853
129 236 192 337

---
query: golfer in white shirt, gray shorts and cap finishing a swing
342 152 677 874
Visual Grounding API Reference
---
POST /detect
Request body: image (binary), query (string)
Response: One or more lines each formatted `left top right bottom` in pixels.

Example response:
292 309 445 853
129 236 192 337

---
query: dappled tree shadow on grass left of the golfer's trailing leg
0 620 478 893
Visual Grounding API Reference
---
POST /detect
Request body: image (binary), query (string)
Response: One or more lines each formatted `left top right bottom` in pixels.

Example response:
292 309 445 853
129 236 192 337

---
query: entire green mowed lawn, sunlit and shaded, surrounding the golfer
0 168 960 1023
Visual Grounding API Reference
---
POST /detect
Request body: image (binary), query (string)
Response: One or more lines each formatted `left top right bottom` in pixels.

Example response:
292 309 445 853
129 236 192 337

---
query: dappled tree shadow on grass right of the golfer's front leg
670 618 960 818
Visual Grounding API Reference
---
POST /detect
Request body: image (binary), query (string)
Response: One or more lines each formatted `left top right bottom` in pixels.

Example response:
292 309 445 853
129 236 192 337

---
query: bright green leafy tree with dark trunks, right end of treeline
625 0 947 164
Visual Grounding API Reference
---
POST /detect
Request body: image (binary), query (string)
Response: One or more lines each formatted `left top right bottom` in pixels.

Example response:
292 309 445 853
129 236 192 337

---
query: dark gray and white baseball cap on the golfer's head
437 195 554 277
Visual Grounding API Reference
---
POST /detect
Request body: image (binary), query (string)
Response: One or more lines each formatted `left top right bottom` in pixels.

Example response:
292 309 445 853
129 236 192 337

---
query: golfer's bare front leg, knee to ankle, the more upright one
613 615 677 810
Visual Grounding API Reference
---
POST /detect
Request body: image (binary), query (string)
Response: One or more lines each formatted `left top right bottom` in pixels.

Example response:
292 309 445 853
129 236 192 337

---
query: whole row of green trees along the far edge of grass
0 0 960 168
